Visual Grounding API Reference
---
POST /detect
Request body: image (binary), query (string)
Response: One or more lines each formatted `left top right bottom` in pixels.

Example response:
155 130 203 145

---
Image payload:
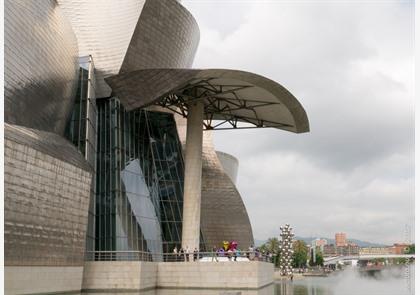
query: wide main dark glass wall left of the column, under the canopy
96 98 205 260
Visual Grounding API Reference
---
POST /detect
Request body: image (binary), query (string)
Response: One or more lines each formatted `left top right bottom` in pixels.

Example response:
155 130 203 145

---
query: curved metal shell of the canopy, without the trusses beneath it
105 69 309 133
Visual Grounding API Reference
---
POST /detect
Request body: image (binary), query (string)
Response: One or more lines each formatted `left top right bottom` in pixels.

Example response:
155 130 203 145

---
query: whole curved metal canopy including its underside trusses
105 69 309 133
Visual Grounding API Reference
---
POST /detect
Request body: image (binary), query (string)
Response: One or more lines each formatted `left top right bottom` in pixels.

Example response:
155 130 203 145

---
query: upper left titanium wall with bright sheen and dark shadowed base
4 0 79 134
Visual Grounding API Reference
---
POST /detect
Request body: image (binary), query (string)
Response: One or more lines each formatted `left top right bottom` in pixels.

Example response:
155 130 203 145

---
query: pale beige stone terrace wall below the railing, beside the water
82 261 274 292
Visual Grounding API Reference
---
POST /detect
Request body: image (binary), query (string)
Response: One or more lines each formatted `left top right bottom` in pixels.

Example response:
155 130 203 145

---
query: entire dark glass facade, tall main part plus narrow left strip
66 77 205 260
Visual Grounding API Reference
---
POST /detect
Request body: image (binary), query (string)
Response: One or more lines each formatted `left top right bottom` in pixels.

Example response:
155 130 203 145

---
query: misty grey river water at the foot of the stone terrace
83 265 414 295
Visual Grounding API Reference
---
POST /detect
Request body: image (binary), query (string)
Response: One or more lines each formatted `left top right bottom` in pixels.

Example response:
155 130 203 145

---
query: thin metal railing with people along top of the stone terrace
85 251 275 263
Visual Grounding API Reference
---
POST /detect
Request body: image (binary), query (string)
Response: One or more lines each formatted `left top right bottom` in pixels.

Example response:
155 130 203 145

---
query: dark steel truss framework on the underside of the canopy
156 78 293 130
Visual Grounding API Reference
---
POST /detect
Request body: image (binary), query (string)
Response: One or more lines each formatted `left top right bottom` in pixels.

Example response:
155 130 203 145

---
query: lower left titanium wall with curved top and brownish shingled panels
4 123 91 266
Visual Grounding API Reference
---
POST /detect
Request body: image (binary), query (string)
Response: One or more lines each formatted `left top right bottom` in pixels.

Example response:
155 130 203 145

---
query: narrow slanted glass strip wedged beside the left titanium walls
66 56 97 251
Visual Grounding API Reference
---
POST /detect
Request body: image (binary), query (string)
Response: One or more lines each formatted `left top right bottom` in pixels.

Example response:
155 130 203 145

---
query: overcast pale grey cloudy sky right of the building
182 0 414 243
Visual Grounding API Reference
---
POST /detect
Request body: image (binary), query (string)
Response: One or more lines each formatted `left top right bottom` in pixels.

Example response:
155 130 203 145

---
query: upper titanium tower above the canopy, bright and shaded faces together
58 0 199 98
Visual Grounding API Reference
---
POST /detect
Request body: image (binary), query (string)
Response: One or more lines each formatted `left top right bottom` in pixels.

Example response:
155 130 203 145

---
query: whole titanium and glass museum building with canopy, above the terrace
4 0 309 292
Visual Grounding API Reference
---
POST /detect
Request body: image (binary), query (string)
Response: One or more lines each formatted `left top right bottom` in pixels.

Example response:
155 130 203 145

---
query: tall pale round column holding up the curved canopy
182 101 204 251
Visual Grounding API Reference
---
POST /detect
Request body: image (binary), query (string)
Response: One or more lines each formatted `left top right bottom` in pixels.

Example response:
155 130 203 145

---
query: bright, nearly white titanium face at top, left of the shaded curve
58 0 146 98
